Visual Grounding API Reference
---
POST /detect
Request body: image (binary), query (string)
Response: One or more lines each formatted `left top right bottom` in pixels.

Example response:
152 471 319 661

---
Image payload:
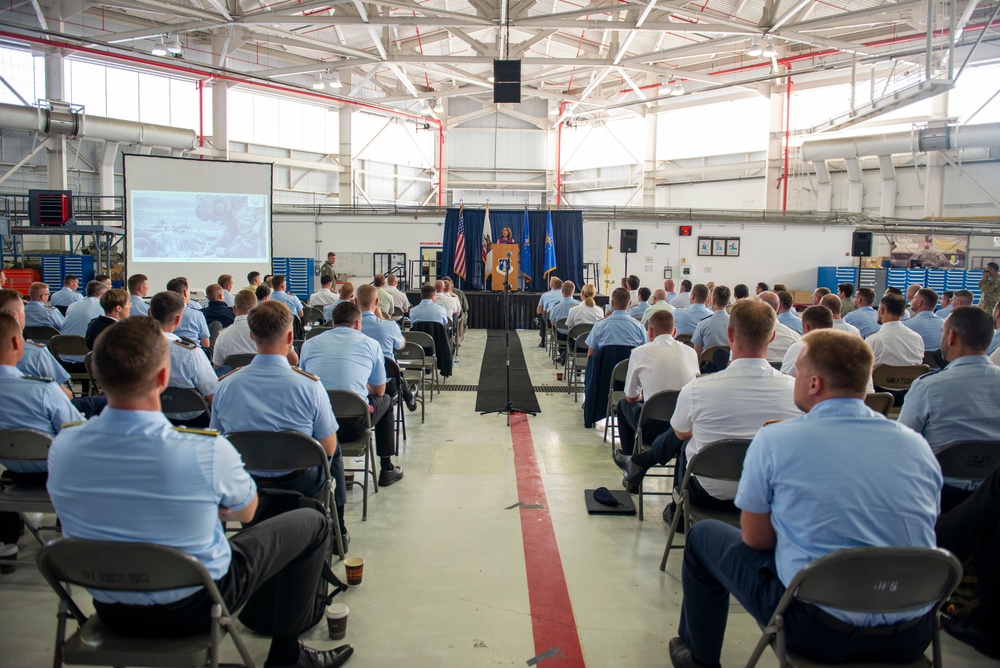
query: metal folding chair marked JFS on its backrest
747 547 962 668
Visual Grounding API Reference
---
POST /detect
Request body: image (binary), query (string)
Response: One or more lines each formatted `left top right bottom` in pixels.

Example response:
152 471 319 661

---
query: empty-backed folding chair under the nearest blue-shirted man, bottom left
38 538 254 668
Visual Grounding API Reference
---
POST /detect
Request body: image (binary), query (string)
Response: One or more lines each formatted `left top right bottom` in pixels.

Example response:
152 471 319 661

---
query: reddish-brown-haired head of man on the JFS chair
798 328 875 395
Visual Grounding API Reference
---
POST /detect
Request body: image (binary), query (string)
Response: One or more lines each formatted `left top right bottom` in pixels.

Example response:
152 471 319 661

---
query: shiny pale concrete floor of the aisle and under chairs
0 331 1000 668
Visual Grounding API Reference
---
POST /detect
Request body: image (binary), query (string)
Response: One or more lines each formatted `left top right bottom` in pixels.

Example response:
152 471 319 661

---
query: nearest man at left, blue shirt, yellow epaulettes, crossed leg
48 318 353 668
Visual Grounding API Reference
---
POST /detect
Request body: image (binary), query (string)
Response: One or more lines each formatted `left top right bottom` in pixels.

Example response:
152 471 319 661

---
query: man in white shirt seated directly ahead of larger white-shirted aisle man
612 310 698 473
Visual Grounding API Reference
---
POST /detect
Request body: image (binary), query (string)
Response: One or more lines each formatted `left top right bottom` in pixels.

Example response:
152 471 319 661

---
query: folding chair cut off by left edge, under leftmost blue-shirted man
0 428 59 545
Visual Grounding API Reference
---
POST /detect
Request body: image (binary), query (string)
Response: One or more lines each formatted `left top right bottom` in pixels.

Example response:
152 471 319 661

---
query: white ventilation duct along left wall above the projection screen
0 104 198 149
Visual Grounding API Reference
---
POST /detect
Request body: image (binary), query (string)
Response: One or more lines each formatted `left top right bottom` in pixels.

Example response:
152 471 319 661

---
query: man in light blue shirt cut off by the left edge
0 314 83 561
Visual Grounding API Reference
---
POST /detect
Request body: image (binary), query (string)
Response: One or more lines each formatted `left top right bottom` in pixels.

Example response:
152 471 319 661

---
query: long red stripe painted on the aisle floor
510 413 584 668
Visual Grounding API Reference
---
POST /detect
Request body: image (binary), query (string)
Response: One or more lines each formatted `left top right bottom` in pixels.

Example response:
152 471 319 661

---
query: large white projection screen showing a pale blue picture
123 154 272 295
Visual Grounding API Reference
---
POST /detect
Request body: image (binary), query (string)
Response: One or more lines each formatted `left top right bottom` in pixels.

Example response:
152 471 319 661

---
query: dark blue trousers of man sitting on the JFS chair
679 520 934 666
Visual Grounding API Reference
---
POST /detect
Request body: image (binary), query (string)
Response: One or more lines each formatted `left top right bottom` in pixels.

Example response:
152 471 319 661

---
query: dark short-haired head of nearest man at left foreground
91 318 168 399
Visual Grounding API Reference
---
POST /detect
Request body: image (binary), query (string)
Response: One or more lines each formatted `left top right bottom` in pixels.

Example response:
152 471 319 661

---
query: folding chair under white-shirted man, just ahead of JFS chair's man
660 438 750 571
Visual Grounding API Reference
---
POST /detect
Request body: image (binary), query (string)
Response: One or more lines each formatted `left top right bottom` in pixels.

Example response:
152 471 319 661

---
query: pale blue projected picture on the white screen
129 190 270 262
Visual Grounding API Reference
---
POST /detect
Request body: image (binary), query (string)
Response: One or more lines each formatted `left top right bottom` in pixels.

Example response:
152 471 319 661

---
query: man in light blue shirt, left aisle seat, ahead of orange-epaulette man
302 302 403 487
